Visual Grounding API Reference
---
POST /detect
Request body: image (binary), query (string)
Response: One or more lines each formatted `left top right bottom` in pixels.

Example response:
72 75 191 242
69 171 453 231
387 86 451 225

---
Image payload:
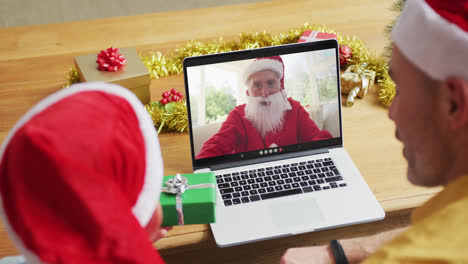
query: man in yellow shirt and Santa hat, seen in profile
281 0 468 264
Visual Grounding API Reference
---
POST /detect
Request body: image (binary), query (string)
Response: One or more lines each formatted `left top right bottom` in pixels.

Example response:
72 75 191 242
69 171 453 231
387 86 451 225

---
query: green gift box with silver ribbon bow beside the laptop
160 172 216 226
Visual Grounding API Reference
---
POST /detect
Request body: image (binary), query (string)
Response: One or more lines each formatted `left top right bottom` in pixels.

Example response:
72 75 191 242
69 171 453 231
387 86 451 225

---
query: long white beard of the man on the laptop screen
245 91 291 138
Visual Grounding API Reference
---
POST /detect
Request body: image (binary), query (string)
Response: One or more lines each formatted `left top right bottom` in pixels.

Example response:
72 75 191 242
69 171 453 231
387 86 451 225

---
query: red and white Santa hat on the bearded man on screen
244 56 284 90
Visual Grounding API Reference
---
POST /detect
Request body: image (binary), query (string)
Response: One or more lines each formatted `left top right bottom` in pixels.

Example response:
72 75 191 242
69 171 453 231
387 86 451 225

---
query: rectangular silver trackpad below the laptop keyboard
270 198 325 227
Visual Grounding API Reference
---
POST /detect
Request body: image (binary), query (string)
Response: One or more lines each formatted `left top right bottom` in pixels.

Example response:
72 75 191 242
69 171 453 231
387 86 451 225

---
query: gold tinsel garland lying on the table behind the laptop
66 24 395 132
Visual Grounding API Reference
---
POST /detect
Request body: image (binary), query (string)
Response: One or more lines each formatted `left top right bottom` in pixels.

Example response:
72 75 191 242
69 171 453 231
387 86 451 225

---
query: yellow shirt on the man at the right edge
365 191 468 263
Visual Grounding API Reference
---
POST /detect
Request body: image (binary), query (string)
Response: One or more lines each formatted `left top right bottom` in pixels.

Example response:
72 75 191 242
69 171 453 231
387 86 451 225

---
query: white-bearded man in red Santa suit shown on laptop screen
196 56 332 159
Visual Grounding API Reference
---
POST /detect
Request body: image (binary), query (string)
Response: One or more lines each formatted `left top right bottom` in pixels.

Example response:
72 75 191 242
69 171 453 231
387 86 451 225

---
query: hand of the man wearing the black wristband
280 245 335 264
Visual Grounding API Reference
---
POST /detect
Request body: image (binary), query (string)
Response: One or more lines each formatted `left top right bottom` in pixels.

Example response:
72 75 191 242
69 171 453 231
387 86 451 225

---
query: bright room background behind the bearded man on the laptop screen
187 49 341 161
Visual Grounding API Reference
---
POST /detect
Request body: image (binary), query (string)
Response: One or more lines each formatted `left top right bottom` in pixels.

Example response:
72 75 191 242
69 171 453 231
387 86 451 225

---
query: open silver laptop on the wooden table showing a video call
183 39 385 247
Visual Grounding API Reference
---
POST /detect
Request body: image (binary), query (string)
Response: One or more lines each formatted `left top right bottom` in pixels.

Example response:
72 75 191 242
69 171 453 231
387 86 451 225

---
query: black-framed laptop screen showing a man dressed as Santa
184 40 342 170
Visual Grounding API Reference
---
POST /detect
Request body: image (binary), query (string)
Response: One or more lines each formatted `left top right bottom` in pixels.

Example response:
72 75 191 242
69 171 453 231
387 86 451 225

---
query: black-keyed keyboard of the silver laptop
216 158 347 206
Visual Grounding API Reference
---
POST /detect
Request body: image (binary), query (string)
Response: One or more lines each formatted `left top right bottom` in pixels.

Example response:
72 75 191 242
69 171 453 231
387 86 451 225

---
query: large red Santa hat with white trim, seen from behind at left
0 83 164 264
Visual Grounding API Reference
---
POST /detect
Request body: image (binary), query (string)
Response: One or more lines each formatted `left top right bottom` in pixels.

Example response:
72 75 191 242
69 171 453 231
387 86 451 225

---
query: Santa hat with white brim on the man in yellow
392 0 468 80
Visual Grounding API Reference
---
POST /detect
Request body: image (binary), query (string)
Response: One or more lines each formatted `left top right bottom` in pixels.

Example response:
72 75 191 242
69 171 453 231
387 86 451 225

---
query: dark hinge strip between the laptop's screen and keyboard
202 149 330 171
